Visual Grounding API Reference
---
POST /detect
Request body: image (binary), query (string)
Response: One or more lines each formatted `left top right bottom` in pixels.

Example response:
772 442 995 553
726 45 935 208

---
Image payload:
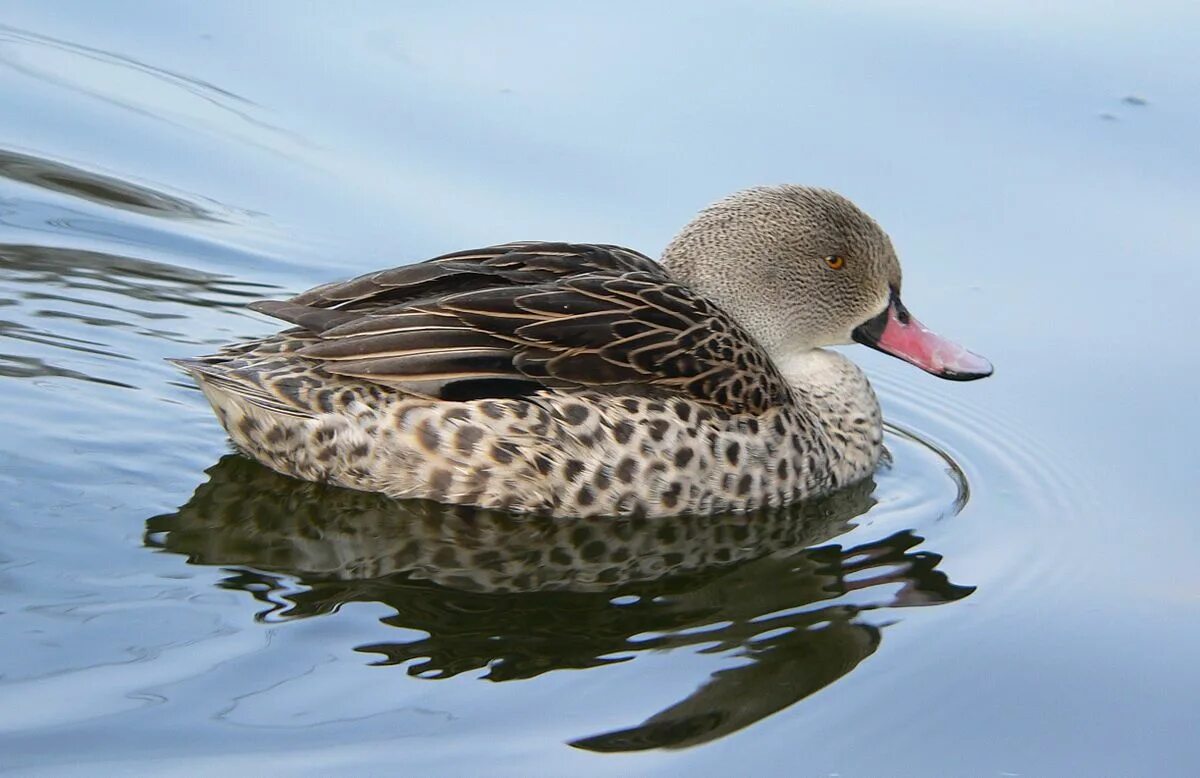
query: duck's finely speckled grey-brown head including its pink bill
662 185 991 381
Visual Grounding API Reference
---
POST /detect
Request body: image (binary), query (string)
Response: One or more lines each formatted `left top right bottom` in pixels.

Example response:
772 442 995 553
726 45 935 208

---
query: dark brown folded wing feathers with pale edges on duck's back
244 244 784 412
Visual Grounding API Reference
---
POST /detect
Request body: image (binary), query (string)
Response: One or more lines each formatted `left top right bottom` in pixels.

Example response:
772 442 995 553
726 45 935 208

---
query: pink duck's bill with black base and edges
852 294 991 381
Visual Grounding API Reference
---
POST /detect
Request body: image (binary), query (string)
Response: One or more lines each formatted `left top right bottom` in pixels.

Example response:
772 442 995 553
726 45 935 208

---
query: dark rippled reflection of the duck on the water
145 455 972 752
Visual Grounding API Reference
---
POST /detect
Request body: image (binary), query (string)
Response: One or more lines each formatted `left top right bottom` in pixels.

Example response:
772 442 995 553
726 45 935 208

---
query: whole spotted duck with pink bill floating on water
173 185 992 517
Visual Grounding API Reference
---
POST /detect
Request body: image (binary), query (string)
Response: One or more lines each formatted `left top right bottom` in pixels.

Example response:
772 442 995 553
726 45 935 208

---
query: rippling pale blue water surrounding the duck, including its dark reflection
0 0 1200 776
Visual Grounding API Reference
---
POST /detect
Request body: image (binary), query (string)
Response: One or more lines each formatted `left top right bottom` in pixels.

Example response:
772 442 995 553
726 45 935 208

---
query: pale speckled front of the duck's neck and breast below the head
779 348 883 483
